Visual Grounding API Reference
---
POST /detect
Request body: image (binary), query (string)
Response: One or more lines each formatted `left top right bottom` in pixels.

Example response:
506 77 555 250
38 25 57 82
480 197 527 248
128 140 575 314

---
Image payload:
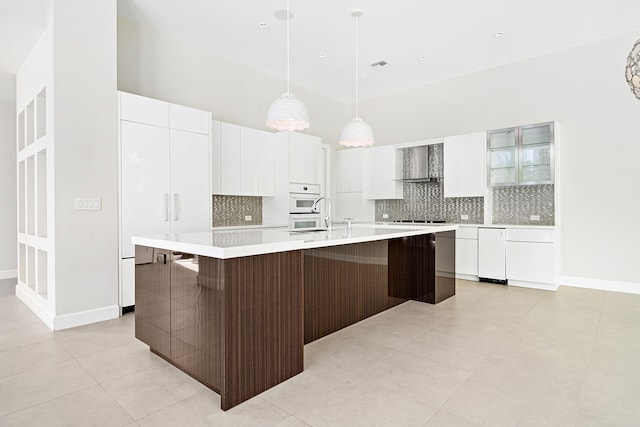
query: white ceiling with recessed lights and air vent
0 0 640 102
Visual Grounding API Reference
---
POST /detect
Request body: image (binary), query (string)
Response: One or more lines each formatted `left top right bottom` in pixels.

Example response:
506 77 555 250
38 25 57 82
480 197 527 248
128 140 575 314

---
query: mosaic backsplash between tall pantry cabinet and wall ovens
212 194 262 227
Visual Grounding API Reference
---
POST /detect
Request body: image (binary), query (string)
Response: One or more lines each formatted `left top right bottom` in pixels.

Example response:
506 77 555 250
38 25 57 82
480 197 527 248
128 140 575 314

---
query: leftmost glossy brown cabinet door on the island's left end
135 249 171 359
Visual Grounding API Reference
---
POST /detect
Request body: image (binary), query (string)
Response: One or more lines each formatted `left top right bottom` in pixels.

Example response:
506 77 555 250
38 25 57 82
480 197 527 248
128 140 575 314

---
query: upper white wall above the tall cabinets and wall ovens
118 18 351 144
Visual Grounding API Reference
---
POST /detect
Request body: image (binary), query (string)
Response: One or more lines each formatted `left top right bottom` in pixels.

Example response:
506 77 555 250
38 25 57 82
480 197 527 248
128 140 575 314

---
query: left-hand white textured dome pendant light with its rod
267 0 310 131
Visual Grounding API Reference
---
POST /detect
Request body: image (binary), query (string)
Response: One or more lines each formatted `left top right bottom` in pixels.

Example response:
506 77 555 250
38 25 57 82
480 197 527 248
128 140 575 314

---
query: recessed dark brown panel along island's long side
304 240 407 344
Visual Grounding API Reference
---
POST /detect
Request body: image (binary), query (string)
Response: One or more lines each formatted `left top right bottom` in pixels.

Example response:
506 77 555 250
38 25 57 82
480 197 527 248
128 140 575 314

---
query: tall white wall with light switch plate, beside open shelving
53 0 118 316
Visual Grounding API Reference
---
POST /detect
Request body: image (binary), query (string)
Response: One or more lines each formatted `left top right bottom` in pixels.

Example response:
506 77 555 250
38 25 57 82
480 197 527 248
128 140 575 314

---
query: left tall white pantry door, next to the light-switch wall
120 121 170 258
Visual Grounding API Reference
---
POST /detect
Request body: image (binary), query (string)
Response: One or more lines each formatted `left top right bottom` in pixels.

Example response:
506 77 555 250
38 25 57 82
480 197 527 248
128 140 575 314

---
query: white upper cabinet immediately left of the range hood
365 145 403 200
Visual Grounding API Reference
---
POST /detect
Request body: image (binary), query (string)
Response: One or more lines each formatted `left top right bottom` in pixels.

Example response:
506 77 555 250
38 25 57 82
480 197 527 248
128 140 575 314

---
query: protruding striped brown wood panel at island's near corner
219 251 304 410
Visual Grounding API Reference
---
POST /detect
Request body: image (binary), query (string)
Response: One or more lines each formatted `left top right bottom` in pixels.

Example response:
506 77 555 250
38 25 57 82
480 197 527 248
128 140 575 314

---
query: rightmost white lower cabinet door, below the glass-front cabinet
507 242 555 284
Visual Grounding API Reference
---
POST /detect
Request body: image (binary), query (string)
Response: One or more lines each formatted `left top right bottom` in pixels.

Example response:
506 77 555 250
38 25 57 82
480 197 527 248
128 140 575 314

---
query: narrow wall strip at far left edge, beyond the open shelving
0 102 17 279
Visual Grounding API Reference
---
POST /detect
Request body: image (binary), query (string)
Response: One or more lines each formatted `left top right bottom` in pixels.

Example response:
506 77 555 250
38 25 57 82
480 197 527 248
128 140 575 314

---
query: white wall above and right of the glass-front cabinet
360 33 640 287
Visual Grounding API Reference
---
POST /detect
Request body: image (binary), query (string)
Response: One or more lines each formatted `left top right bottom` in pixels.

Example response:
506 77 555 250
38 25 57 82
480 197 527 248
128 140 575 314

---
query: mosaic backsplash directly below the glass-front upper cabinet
492 184 555 225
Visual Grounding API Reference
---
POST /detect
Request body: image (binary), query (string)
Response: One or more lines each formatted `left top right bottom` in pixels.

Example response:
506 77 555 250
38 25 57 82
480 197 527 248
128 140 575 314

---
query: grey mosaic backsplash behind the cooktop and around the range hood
375 144 484 224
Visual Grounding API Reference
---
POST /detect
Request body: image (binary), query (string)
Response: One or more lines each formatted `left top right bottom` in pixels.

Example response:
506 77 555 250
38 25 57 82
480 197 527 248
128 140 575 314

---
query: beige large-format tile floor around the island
0 281 640 427
